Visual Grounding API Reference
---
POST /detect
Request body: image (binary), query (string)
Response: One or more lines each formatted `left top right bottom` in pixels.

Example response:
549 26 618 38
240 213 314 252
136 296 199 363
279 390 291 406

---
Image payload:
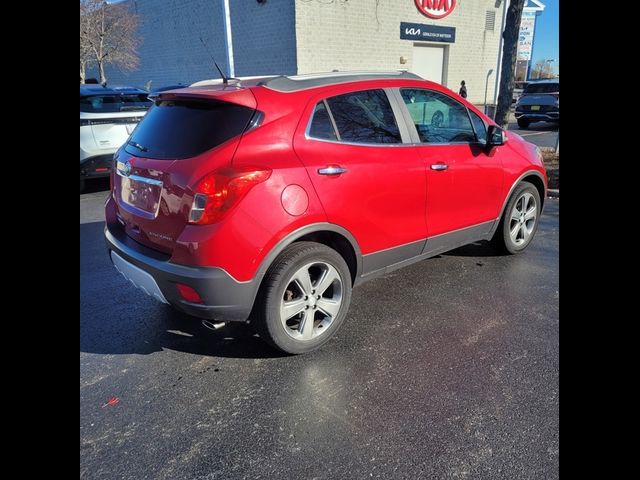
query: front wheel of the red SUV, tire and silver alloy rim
491 182 541 254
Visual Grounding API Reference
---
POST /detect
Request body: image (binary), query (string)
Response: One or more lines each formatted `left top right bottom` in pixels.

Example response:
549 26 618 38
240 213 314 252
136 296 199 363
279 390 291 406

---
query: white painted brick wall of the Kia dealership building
295 0 504 103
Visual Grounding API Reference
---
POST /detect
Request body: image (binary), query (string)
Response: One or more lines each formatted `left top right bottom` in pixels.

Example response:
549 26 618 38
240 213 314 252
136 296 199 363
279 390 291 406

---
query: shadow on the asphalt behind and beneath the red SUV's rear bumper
80 222 284 358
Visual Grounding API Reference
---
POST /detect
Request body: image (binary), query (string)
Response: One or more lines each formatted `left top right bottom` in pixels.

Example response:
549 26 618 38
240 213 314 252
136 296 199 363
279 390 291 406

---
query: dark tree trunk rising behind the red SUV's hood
495 0 526 128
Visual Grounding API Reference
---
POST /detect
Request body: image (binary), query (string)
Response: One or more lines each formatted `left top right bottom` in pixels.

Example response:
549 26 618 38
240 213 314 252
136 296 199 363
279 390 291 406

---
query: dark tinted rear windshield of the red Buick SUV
125 99 254 160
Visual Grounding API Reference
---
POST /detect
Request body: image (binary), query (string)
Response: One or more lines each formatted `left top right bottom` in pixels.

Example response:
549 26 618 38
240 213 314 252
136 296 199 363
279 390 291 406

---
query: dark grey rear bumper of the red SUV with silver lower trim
104 221 259 321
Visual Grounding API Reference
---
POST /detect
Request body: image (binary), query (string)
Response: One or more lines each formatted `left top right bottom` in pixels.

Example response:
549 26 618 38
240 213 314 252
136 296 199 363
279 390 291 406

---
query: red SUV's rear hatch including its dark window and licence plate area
112 88 256 254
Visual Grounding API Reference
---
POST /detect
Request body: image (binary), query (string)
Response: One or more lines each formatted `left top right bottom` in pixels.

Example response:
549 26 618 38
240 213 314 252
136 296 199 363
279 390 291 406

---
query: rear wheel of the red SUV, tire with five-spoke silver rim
252 242 352 354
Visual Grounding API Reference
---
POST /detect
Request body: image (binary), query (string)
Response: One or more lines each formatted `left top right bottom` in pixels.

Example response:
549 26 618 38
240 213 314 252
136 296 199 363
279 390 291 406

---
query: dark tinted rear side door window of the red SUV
327 90 402 143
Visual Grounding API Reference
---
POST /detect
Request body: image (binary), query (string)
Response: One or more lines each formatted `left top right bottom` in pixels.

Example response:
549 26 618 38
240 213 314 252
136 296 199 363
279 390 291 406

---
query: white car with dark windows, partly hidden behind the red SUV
80 85 153 192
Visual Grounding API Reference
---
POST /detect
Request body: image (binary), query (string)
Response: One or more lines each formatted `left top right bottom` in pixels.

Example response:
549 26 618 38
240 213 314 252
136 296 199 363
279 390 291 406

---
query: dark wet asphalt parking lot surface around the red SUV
80 187 559 480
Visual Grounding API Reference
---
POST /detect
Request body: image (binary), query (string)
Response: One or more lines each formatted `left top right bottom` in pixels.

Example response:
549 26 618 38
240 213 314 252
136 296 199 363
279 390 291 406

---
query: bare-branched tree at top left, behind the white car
80 0 140 84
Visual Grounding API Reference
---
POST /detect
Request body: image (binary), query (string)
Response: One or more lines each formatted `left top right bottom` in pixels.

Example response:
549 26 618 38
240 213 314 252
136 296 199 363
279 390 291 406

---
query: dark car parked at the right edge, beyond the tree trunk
516 79 560 128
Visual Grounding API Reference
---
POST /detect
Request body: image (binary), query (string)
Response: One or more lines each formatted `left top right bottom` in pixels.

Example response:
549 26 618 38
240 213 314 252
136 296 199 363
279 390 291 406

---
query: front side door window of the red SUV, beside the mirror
400 88 476 143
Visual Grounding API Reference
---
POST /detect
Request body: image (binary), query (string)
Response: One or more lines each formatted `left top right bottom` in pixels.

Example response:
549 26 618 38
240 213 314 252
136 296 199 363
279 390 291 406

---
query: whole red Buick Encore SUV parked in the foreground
105 72 547 353
